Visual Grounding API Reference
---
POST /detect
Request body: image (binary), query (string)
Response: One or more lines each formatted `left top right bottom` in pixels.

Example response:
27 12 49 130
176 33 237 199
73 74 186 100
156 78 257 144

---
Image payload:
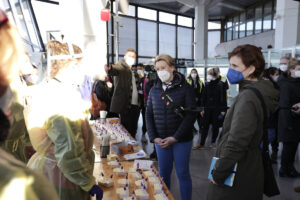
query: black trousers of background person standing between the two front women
200 110 219 145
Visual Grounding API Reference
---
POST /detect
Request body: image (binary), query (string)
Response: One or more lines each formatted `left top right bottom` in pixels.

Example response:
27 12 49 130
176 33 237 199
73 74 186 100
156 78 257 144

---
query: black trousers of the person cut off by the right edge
281 142 298 171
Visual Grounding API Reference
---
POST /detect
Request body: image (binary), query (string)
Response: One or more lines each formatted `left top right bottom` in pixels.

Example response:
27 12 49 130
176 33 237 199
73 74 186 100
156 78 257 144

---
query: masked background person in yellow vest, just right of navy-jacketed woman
186 68 204 143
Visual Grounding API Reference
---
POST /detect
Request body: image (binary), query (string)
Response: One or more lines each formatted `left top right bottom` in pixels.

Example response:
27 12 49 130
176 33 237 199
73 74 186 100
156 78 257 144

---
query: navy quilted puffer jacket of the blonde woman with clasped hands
146 72 196 142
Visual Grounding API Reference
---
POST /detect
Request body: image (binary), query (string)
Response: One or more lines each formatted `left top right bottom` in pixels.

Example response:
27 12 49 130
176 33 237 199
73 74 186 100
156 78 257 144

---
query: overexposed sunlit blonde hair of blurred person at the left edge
0 22 26 84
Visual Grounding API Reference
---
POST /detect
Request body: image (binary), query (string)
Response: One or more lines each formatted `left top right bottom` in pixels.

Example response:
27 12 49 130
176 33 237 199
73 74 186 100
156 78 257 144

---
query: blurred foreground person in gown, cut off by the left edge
0 9 58 200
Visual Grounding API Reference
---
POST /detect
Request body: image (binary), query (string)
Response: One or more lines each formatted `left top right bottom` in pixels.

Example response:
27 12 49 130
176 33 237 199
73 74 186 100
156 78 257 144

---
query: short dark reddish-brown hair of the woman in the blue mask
228 44 265 78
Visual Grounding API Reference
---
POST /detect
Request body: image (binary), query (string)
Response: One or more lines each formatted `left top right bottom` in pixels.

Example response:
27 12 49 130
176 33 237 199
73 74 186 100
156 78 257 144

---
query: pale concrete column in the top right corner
275 0 300 49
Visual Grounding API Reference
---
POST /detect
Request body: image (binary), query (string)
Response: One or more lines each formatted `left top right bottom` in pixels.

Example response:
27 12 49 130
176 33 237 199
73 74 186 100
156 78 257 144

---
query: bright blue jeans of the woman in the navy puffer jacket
155 141 192 200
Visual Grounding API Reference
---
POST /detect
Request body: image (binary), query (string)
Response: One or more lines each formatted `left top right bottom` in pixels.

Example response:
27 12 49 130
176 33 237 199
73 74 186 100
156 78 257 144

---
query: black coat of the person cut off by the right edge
278 75 300 142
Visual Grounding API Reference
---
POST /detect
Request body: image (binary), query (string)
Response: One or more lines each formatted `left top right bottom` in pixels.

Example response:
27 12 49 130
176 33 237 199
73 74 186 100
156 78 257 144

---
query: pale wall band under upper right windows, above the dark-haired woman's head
215 30 275 56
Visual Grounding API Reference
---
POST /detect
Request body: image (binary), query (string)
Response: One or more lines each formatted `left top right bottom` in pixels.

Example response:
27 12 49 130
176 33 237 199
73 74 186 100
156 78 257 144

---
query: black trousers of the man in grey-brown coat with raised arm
121 105 140 138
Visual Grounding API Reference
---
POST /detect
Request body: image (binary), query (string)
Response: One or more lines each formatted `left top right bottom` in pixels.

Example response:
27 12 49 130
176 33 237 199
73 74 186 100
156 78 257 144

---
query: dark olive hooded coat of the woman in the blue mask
208 80 279 200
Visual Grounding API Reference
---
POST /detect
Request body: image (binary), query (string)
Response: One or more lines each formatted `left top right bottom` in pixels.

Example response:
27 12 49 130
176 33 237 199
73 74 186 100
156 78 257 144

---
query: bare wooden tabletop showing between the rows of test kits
94 119 174 200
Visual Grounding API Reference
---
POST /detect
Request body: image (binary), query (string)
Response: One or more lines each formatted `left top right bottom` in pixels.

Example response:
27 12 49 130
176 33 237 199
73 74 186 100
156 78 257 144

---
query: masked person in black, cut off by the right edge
278 59 300 177
